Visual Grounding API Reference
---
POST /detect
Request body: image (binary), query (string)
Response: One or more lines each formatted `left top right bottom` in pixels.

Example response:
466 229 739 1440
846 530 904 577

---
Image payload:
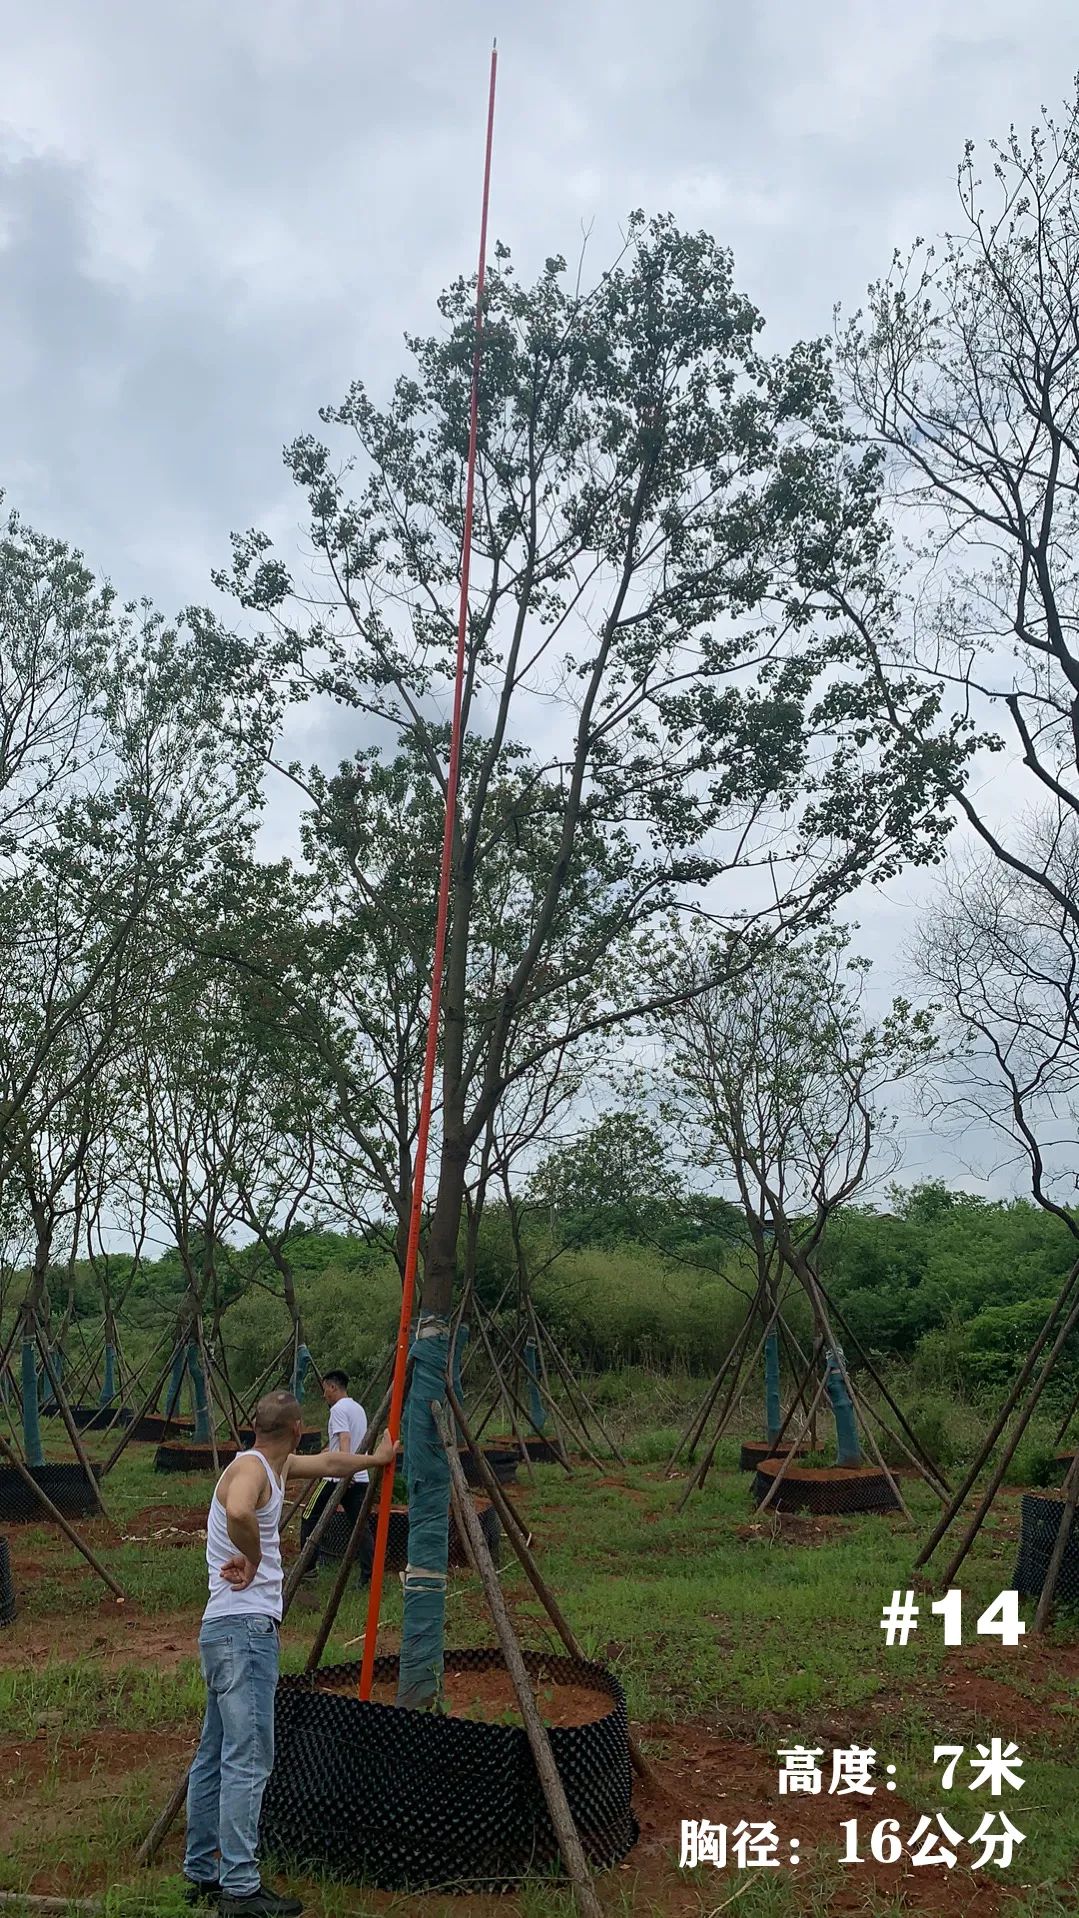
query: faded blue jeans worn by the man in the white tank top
184 1615 278 1899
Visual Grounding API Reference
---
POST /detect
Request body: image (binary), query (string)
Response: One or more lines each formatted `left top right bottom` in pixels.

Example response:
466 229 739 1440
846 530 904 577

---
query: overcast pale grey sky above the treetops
0 0 1079 1176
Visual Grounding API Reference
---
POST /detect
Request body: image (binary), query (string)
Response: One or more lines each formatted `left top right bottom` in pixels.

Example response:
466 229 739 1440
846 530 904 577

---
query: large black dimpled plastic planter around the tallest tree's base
263 1651 638 1891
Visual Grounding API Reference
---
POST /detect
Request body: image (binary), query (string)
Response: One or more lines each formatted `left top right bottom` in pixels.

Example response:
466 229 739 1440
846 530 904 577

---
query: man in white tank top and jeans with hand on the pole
184 1392 399 1918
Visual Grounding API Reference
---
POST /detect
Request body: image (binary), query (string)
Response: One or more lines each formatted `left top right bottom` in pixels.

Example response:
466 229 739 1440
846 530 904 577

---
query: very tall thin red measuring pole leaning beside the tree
360 42 498 1697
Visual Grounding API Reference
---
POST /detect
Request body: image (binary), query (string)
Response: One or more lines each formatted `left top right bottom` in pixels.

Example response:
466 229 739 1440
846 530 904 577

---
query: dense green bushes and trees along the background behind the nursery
13 1183 1079 1406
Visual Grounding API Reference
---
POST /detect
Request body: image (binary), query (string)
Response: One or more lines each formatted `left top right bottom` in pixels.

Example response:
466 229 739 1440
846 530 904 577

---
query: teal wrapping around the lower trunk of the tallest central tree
397 1314 450 1709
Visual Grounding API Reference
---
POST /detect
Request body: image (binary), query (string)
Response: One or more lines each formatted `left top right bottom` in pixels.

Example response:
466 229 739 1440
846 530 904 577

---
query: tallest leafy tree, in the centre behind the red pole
217 215 954 1703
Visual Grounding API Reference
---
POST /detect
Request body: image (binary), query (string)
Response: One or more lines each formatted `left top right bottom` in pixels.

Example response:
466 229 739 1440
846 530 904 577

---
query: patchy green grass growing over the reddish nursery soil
0 1403 1079 1918
